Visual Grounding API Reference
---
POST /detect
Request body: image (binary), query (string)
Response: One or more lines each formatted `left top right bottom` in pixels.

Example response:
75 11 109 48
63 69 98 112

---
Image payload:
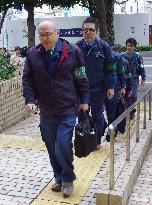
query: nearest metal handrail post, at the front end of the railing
108 125 114 190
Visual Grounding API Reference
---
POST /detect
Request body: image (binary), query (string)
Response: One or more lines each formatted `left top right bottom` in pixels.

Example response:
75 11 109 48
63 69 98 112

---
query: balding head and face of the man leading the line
39 24 59 50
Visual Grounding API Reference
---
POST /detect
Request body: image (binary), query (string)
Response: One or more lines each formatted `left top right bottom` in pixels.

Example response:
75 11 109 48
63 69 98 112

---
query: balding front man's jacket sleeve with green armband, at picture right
73 46 89 104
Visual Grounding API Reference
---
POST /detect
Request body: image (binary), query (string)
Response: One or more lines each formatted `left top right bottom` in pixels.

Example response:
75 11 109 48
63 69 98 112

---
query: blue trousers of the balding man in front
40 114 76 183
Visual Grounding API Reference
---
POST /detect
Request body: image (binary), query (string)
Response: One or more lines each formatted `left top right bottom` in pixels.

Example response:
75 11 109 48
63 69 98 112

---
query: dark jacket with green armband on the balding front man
23 39 89 117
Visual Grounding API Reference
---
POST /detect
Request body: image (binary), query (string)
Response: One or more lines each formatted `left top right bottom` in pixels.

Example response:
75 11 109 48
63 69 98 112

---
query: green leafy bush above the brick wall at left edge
0 52 16 81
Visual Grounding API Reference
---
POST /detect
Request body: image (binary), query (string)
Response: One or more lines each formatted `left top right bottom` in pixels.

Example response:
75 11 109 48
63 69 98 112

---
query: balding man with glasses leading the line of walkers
23 20 89 197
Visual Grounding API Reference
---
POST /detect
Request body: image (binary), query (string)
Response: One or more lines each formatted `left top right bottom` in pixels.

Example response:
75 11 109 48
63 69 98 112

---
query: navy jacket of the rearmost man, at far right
122 52 146 81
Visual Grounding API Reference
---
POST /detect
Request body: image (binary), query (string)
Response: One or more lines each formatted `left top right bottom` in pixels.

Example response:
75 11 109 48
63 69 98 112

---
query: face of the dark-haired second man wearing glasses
82 23 97 43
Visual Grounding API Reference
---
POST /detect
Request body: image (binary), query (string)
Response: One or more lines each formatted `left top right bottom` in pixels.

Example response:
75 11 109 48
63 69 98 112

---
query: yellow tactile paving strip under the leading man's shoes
31 146 109 205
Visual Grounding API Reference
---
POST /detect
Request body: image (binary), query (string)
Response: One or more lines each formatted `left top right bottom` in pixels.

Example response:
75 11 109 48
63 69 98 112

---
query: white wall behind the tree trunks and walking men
0 14 150 50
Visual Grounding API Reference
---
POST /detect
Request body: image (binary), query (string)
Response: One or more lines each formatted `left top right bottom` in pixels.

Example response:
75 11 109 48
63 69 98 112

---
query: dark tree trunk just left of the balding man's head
24 3 36 46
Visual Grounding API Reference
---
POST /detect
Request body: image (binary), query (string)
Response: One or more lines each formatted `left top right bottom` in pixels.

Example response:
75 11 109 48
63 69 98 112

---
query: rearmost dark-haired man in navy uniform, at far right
122 38 146 119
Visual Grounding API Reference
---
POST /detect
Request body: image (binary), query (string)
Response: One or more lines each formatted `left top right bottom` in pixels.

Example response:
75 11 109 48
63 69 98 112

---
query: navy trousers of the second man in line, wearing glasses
90 89 105 145
